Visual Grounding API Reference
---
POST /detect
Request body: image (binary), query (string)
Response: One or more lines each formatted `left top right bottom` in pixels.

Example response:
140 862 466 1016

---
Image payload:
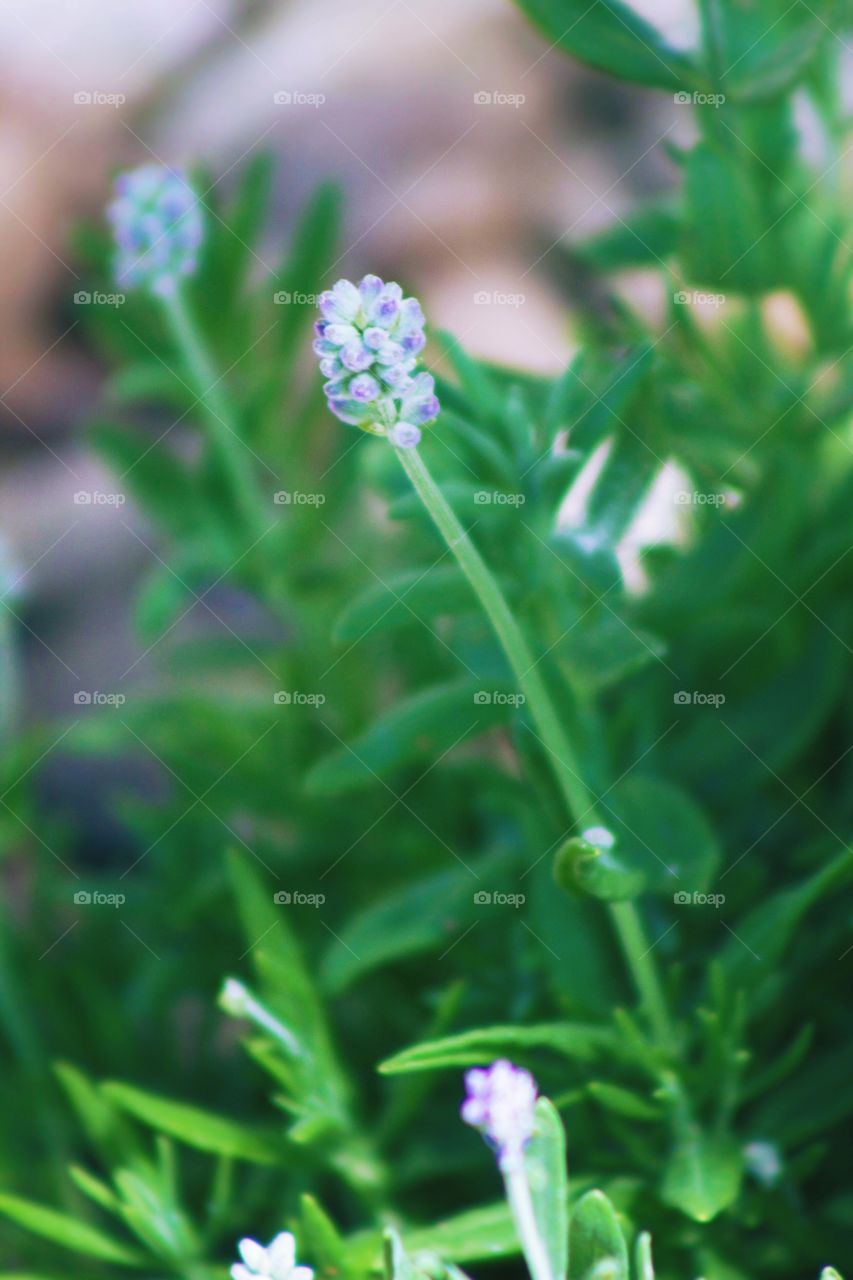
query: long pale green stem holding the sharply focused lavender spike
394 449 671 1043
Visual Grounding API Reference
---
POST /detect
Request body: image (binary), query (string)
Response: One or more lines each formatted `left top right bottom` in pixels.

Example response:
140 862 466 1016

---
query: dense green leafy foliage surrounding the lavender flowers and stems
0 0 853 1280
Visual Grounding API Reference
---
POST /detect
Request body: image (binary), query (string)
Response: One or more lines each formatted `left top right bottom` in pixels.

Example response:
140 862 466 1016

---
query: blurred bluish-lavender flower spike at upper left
106 164 204 297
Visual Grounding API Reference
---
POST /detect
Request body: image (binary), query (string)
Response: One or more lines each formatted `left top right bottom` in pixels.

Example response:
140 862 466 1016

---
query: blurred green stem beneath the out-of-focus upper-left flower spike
163 289 266 539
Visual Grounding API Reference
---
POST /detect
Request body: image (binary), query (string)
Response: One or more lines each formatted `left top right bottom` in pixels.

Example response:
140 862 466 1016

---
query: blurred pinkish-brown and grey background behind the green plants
0 0 695 851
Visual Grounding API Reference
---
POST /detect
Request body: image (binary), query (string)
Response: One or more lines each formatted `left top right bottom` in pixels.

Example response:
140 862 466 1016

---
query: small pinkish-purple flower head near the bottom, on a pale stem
461 1059 537 1170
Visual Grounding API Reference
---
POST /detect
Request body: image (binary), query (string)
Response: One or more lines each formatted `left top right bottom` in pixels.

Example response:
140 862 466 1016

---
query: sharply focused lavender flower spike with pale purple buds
314 275 441 449
